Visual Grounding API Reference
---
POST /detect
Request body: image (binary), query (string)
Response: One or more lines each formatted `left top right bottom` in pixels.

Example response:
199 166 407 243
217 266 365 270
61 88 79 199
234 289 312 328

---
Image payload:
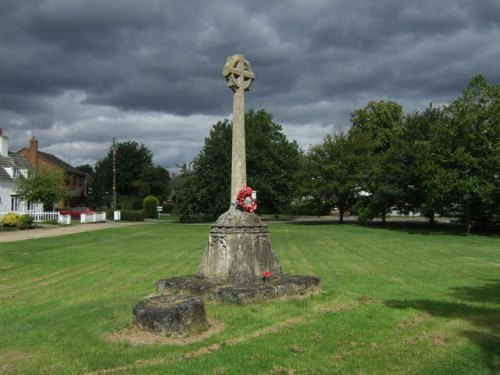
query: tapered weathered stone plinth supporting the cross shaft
198 209 281 285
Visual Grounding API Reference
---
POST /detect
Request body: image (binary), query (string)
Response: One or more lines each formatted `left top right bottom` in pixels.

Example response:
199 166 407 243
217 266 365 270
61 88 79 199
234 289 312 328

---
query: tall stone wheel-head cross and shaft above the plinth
222 54 255 208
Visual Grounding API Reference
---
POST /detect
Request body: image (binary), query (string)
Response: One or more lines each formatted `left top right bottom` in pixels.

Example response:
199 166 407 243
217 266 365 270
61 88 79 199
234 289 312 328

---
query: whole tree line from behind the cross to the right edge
177 75 500 230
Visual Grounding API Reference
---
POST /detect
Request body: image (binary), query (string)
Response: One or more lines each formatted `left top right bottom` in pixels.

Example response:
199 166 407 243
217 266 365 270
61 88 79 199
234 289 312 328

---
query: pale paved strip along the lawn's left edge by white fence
0 221 141 242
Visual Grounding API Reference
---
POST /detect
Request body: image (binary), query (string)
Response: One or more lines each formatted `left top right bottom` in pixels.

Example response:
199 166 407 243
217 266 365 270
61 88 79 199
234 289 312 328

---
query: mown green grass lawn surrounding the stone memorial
0 222 500 375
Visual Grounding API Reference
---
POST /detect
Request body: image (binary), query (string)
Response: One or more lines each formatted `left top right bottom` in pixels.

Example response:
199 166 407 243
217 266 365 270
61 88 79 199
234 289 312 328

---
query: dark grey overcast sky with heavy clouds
0 0 500 170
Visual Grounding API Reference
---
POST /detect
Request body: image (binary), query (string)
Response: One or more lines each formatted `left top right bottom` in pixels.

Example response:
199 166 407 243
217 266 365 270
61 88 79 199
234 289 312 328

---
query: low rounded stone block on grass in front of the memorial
133 295 209 337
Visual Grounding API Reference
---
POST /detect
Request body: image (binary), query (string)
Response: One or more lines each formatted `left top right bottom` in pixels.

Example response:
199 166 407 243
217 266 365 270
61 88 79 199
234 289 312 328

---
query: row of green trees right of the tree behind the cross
299 75 500 230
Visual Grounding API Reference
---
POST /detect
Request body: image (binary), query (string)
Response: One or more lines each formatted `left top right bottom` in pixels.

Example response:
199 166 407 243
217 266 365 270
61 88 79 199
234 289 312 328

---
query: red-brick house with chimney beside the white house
17 136 90 208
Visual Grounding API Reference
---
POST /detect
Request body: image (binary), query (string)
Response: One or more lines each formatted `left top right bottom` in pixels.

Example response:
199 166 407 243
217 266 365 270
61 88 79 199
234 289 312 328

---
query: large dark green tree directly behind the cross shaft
177 110 300 221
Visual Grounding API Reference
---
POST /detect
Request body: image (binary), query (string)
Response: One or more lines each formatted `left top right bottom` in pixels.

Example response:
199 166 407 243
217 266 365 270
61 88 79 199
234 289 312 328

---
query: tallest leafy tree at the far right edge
426 75 500 231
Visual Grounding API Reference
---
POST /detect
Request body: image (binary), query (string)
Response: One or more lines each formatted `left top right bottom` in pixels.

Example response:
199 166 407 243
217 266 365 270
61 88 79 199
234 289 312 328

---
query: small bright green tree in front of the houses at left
17 169 67 211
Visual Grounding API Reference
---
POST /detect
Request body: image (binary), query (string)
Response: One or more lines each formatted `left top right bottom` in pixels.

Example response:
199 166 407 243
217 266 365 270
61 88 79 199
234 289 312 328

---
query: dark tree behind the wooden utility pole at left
93 141 153 206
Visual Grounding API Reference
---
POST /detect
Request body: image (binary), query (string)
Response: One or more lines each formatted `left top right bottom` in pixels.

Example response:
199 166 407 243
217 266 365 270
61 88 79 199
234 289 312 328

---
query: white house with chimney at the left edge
0 128 41 212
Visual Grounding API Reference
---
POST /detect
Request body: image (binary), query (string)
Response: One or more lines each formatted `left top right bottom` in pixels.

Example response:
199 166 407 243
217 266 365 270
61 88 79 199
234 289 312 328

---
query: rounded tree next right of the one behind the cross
304 129 375 222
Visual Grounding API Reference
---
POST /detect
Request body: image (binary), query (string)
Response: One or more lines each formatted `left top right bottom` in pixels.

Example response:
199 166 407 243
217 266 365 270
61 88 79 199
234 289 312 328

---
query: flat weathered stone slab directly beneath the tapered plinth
156 275 321 304
